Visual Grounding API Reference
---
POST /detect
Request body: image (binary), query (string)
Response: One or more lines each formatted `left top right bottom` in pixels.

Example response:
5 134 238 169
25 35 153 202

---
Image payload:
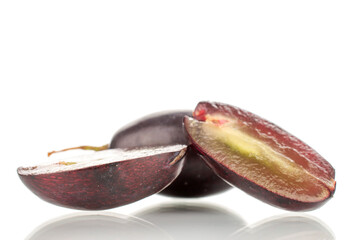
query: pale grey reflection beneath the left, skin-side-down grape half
26 213 171 240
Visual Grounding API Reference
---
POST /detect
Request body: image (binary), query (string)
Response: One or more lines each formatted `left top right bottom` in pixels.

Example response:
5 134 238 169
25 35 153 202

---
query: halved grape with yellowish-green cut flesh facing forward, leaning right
184 102 335 210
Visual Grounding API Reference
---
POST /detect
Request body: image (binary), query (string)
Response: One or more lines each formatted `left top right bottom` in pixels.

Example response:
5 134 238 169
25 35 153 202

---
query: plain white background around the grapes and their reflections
0 0 360 239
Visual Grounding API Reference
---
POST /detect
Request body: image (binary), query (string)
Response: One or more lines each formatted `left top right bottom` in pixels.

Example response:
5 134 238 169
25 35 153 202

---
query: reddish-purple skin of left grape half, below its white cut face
18 148 186 210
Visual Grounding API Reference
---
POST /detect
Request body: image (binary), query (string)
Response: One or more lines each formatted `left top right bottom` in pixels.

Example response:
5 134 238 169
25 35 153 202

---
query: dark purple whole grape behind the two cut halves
110 111 230 198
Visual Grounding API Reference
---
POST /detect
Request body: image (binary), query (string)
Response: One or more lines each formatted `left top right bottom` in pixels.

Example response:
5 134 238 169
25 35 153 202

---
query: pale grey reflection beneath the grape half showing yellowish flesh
229 215 335 240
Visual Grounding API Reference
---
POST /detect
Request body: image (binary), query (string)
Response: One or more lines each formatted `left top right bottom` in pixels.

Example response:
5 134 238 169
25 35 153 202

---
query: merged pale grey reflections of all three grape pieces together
26 204 335 240
